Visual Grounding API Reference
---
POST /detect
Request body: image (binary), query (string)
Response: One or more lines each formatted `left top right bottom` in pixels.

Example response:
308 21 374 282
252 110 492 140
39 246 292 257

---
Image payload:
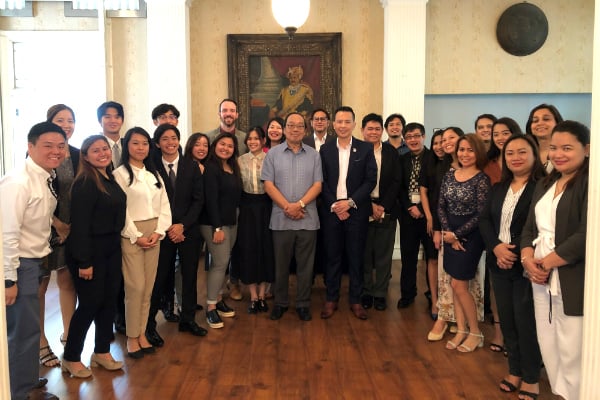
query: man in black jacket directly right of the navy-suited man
361 113 402 311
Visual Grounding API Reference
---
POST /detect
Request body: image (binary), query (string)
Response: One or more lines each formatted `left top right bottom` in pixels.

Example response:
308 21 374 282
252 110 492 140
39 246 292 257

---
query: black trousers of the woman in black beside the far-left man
64 233 123 361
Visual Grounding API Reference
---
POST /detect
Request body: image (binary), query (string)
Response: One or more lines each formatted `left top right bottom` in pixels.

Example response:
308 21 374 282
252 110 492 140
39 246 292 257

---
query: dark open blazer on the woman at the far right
521 175 588 316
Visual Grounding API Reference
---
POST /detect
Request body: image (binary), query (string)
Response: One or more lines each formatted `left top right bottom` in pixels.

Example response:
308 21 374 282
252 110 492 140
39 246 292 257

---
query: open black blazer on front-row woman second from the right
479 181 535 274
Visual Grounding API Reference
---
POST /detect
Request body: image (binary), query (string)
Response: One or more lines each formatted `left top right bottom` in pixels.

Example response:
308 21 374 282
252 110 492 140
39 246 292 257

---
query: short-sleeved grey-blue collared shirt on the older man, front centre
260 144 323 231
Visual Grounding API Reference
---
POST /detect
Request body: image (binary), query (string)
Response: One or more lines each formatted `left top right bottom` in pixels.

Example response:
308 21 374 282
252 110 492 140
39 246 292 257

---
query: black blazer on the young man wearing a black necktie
154 154 204 231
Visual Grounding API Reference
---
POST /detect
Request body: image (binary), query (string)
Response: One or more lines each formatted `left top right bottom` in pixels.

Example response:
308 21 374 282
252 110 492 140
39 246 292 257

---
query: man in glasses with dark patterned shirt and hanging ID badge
397 122 437 308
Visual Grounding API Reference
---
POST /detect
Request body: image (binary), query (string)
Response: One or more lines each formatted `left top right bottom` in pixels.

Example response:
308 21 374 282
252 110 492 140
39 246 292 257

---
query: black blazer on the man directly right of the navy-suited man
376 143 402 219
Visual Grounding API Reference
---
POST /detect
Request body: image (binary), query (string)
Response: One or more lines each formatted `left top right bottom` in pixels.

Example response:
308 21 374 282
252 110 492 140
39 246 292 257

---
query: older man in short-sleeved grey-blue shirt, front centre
261 113 323 321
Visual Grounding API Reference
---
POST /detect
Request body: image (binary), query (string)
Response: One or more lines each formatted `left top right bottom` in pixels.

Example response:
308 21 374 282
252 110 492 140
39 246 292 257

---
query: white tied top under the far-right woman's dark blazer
533 182 563 296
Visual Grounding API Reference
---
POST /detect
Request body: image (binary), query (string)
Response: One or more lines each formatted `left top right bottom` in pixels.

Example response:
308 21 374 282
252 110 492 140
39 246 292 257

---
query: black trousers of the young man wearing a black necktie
147 230 200 329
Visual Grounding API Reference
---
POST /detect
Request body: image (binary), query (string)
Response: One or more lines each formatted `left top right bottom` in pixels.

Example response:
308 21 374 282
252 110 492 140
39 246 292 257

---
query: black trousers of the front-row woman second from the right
488 264 542 383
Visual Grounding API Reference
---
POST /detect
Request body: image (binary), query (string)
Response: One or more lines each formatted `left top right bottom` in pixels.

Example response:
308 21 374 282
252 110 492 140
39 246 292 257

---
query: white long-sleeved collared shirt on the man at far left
0 158 56 281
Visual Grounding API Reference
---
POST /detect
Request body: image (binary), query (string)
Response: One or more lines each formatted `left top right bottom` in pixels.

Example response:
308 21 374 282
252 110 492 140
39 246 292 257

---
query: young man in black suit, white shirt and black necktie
146 124 207 346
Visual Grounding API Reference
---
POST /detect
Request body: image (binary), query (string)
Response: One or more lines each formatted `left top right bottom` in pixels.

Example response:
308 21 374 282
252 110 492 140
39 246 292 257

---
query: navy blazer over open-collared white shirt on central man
320 137 377 219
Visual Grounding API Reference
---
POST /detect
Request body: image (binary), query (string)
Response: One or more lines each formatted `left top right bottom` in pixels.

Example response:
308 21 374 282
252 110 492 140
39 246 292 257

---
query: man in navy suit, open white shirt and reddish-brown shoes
320 106 377 319
